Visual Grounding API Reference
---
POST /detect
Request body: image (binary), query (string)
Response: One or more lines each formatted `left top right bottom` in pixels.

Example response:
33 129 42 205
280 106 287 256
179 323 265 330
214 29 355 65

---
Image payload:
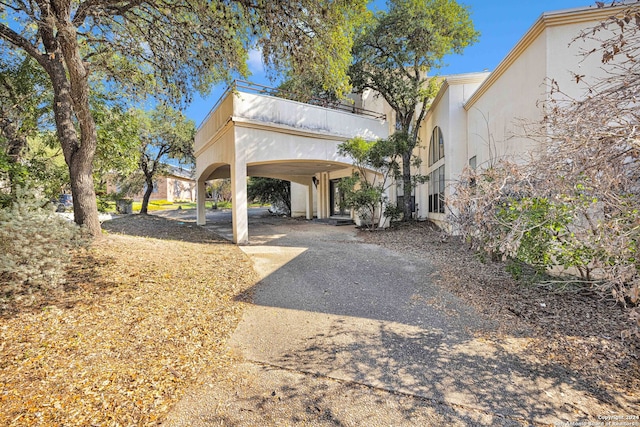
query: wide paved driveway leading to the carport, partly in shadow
167 216 615 425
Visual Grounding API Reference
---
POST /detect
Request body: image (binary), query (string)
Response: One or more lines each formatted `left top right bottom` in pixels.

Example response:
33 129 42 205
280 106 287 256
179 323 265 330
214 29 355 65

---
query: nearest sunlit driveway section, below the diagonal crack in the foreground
164 362 522 427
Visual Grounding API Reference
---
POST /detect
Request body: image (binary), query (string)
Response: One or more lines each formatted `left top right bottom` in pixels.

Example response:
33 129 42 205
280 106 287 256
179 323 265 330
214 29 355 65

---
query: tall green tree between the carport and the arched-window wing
350 0 478 220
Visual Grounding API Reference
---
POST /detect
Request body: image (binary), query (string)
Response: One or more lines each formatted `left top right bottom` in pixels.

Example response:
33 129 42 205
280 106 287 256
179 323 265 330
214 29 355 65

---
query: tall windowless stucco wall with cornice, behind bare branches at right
466 8 611 171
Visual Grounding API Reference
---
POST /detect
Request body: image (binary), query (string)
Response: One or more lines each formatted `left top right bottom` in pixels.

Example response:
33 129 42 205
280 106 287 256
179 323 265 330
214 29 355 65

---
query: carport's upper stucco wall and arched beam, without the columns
195 93 388 183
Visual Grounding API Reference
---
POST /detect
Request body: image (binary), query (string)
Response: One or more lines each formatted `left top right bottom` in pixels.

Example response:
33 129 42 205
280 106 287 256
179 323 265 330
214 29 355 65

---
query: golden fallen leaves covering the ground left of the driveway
0 215 256 426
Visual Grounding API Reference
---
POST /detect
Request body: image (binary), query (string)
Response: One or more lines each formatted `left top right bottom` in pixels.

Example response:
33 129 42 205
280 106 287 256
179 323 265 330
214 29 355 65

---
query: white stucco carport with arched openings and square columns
195 83 389 244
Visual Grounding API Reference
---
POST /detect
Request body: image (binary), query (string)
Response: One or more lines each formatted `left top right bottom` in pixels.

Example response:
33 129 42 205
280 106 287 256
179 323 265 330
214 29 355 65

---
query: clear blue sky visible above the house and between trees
186 0 595 125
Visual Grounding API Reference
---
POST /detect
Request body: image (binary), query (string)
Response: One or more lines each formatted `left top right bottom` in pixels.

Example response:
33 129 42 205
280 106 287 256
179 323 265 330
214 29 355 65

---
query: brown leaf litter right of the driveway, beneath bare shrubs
359 222 640 403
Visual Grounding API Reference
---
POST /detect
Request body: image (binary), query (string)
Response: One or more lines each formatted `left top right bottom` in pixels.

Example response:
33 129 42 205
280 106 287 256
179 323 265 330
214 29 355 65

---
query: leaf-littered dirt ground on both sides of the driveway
0 215 640 426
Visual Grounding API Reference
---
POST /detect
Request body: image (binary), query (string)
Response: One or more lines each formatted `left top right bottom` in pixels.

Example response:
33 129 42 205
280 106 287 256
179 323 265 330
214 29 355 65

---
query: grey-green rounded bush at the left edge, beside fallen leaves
0 192 85 306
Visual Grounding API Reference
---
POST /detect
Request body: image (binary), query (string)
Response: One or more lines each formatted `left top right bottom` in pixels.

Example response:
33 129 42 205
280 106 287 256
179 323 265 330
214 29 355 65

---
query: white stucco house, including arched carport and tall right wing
195 2 624 243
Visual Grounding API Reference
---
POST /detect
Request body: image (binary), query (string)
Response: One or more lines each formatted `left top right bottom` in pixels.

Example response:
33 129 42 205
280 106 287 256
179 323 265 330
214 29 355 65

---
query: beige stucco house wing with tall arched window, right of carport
416 7 624 231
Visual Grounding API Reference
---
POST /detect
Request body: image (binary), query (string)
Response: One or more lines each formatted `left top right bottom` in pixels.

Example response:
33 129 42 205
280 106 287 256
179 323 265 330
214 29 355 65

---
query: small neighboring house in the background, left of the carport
107 166 196 202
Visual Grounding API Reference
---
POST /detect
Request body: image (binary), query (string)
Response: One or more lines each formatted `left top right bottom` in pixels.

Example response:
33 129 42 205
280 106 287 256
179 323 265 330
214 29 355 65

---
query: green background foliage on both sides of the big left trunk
0 54 139 205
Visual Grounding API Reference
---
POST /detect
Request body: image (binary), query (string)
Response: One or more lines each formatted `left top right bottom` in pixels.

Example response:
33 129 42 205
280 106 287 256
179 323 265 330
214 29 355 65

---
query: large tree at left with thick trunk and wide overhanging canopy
0 0 364 235
